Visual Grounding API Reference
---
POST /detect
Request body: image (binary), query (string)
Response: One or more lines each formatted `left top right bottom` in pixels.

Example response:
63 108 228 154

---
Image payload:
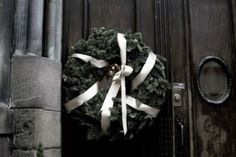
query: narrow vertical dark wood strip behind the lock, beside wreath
168 0 191 157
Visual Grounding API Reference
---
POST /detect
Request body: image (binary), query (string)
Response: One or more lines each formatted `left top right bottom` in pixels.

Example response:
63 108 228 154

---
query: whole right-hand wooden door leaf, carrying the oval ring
169 0 236 157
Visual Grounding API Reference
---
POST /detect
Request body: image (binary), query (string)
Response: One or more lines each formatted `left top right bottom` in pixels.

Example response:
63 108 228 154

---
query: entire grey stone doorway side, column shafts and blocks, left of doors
0 0 63 157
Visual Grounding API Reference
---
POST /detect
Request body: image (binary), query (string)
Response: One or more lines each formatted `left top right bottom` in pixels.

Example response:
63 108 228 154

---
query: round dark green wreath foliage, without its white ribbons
62 27 169 140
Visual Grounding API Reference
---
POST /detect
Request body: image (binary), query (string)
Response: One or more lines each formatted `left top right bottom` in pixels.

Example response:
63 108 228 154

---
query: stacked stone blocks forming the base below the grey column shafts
11 55 61 157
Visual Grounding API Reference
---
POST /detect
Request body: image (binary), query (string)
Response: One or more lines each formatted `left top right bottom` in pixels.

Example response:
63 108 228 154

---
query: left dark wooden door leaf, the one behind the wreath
62 0 173 157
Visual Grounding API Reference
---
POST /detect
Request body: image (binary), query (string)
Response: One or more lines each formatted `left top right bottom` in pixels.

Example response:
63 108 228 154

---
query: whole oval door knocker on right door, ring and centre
197 56 232 104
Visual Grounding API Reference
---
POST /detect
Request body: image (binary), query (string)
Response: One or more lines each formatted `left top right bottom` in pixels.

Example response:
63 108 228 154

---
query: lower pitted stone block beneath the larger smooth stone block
13 109 61 149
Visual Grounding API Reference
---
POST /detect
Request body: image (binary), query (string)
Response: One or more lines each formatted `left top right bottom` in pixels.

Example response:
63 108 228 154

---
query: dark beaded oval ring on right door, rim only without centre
197 56 232 104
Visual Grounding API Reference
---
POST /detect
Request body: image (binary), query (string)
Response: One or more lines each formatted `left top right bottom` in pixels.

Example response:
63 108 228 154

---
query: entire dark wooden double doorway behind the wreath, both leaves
63 0 236 157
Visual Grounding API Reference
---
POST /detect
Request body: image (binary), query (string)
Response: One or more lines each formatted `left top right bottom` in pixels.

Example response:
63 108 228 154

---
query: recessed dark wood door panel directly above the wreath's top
89 0 135 32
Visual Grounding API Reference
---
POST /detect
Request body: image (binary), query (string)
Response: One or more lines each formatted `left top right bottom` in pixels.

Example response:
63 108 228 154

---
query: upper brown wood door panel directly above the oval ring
190 0 233 62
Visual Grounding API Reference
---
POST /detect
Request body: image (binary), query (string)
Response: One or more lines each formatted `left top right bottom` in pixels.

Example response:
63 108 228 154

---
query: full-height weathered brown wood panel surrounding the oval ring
189 0 236 157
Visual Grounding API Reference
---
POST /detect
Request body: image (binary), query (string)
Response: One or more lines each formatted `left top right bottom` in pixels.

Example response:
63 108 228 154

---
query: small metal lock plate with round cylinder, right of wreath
172 83 185 107
